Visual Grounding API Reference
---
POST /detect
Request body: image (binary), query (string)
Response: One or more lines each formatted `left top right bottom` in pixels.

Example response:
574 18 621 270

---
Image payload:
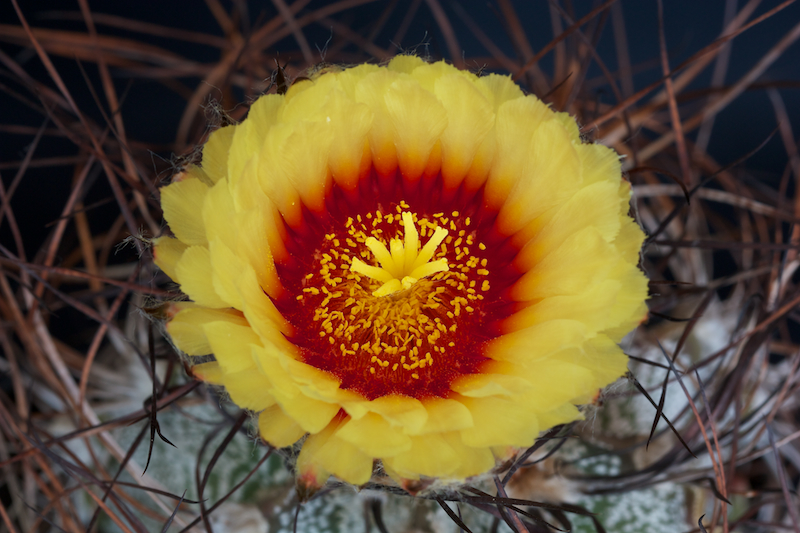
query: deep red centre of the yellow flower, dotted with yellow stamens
276 168 520 399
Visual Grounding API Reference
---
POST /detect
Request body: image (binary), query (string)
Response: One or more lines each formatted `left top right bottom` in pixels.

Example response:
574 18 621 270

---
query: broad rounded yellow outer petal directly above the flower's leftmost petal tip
161 179 208 245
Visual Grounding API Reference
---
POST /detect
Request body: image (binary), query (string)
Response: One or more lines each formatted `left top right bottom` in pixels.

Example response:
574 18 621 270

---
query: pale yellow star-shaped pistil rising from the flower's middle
350 211 449 297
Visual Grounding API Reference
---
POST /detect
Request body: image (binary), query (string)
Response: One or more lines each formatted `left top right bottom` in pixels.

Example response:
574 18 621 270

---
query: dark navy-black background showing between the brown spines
0 0 800 258
